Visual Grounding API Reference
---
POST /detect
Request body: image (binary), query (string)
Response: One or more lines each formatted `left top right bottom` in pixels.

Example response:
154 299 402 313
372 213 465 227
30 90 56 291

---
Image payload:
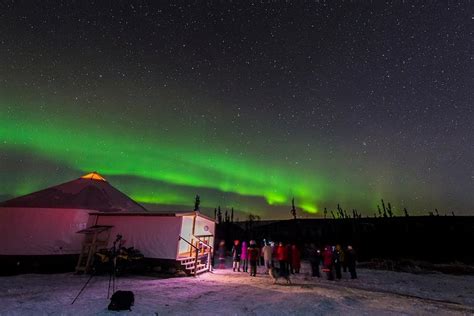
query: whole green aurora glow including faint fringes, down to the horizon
0 94 456 218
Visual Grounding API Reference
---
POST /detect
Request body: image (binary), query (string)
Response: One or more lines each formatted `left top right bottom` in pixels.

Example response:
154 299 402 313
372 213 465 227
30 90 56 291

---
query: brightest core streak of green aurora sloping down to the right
0 102 360 213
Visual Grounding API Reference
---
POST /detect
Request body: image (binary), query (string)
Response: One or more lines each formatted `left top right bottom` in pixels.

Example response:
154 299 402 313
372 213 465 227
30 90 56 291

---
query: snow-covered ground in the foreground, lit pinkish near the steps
0 264 474 315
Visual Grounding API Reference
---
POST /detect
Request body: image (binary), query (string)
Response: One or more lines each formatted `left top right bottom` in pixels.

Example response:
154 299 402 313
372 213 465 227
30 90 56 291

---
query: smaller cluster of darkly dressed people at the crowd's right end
308 244 357 280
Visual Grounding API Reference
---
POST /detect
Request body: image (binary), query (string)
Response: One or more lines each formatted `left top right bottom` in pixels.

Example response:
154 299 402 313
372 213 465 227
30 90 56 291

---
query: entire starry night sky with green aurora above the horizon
0 1 474 218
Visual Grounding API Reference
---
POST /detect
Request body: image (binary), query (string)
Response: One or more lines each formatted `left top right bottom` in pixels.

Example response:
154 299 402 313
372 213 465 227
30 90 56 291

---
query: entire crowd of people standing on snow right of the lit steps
217 240 357 280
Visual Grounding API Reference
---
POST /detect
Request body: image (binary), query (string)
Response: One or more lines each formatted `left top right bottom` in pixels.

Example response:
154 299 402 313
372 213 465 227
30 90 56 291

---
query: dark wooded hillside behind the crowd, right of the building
216 214 474 263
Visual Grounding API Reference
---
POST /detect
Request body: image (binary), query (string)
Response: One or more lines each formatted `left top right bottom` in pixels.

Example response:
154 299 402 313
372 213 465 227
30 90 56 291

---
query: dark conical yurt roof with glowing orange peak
0 172 147 212
